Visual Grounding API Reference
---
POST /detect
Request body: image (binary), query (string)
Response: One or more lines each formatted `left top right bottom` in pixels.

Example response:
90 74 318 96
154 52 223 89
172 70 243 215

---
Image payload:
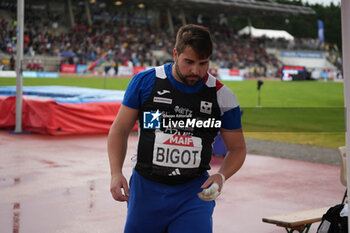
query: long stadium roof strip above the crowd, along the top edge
0 0 315 16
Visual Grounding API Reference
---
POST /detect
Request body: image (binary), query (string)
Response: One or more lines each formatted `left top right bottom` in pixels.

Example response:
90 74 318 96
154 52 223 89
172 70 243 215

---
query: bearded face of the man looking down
172 46 209 86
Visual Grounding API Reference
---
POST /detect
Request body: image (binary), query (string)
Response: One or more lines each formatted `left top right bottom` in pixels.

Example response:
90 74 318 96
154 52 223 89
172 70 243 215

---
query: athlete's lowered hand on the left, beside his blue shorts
111 173 129 201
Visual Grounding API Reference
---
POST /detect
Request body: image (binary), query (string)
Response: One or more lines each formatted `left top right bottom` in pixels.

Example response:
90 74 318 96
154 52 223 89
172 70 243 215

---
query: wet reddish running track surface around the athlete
0 130 345 233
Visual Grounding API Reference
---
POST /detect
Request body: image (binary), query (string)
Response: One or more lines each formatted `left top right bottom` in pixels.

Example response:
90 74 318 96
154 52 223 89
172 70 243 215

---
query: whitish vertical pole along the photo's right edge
341 0 350 231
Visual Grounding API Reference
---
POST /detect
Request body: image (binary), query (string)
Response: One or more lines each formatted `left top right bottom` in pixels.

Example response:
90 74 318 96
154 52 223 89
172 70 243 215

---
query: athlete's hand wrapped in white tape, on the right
198 173 225 201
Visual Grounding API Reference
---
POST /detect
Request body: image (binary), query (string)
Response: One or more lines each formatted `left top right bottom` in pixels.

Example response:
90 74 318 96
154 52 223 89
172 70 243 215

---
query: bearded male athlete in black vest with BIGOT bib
108 25 246 233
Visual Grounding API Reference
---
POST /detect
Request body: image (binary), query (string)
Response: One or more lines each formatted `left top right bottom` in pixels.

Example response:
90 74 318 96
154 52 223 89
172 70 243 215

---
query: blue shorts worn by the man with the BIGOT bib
124 170 215 233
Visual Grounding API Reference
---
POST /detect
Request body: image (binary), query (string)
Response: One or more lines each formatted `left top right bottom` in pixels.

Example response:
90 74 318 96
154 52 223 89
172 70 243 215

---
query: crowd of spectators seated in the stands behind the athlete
0 12 342 75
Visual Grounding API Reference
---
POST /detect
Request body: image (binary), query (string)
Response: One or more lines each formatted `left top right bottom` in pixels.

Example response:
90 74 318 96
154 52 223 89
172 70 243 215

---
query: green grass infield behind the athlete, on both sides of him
0 77 345 148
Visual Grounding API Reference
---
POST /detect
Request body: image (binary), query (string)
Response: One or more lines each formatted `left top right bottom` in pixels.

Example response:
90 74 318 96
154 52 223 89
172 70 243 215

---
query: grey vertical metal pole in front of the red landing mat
15 0 24 133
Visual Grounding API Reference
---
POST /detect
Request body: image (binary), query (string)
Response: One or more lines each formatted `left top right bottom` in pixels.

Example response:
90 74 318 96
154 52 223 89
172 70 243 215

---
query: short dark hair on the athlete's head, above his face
175 24 213 59
